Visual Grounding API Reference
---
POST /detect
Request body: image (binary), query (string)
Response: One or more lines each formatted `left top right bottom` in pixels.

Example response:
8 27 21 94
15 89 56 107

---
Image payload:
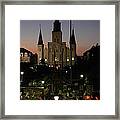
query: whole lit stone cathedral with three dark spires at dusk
37 20 76 69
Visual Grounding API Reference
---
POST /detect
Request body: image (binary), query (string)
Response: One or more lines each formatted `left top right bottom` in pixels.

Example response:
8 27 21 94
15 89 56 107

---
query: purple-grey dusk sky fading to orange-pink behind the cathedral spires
20 20 100 55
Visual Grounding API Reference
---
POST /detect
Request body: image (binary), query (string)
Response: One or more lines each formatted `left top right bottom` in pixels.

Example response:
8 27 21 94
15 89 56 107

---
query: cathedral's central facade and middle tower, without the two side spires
48 20 66 68
